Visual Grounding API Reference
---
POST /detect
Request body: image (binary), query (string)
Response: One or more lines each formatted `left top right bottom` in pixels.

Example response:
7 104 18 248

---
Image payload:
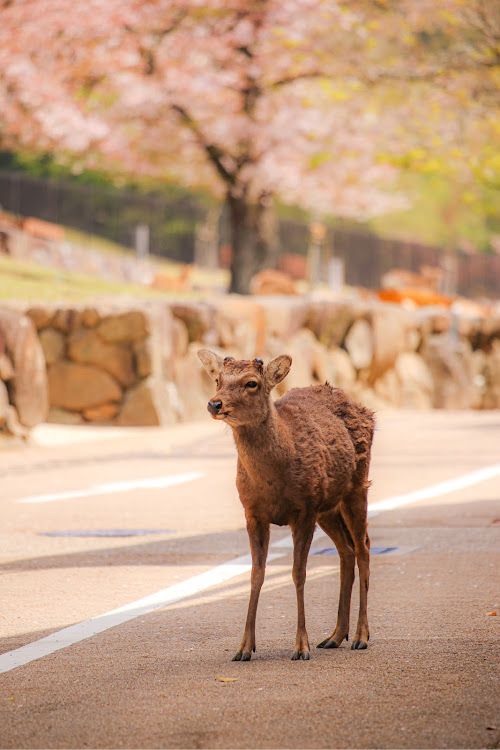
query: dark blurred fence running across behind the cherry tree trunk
0 170 500 298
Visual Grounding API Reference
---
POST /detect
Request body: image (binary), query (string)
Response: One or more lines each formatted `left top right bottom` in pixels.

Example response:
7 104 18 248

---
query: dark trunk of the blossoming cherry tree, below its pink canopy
226 191 278 294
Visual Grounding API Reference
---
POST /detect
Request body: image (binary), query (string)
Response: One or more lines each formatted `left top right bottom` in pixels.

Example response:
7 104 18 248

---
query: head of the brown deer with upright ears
198 349 292 427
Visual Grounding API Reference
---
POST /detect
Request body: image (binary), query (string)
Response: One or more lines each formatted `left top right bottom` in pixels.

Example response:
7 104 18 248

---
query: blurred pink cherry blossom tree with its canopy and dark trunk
0 0 500 292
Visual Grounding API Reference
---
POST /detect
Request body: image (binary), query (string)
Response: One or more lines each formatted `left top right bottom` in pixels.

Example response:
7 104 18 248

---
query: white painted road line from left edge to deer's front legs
0 552 283 674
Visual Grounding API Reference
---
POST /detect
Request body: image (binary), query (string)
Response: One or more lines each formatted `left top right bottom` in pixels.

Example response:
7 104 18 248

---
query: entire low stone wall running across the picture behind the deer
0 296 500 436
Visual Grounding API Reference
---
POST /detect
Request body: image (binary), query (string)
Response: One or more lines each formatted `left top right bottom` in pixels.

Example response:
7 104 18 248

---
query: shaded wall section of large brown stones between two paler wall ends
27 306 178 426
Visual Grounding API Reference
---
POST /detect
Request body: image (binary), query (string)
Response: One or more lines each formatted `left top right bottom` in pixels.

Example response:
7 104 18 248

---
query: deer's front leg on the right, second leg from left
292 518 315 661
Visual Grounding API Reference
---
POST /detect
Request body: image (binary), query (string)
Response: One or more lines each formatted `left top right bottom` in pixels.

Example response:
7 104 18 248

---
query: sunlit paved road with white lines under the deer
0 412 500 748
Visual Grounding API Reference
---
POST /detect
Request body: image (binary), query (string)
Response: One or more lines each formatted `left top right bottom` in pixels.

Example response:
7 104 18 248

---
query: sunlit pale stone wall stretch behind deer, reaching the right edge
167 296 500 416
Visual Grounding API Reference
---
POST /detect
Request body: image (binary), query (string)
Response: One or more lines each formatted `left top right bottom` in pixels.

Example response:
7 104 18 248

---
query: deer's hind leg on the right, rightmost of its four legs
340 482 370 649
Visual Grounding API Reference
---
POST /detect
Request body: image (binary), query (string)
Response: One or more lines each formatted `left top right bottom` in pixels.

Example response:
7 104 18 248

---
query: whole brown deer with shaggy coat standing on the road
198 349 375 661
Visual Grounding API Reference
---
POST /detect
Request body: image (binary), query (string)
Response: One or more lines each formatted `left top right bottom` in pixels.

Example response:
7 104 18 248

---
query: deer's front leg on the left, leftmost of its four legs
233 517 269 661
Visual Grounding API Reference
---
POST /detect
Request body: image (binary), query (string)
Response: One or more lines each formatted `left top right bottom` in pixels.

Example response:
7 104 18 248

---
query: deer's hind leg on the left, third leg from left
317 509 356 648
